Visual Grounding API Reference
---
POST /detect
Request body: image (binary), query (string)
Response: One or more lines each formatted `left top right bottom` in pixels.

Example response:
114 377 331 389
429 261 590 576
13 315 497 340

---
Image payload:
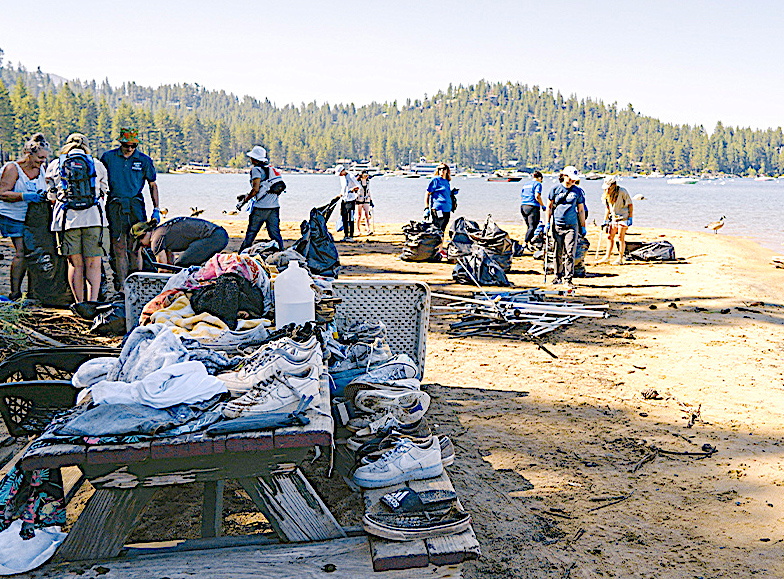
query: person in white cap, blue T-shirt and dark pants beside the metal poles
545 165 585 289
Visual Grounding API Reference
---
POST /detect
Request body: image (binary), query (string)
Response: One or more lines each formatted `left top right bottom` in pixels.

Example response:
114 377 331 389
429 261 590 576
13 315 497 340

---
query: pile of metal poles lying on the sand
432 288 609 346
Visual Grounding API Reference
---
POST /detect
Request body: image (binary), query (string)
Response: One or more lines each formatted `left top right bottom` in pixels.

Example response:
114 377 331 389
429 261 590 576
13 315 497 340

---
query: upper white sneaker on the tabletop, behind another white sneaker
218 336 322 396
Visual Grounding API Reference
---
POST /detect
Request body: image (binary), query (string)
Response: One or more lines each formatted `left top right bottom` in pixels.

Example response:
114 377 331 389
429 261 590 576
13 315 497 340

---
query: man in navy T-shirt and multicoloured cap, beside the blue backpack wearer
101 128 161 290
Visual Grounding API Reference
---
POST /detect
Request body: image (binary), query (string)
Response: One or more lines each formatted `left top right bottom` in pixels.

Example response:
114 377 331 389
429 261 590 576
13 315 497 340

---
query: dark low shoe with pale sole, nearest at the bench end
362 505 471 541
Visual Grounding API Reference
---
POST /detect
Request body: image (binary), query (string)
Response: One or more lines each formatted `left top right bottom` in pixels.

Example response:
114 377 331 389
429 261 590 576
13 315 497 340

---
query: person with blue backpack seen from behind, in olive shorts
46 133 109 302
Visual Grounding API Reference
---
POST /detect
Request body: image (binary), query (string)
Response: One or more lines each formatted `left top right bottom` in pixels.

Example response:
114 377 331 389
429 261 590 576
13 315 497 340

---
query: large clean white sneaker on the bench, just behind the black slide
353 437 444 489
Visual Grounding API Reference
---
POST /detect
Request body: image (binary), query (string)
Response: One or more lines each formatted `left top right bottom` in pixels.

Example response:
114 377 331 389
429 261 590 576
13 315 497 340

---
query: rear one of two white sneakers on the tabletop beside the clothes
218 345 322 396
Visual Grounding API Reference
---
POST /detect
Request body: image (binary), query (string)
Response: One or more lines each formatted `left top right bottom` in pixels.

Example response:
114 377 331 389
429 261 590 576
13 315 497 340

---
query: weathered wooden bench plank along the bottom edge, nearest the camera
20 537 462 579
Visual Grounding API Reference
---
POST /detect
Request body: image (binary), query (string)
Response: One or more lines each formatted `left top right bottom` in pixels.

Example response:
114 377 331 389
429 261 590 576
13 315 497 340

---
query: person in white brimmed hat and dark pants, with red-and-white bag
237 145 286 251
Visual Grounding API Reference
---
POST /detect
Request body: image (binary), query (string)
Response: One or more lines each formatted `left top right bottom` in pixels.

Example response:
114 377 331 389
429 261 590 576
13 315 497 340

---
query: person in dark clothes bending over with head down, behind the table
131 217 229 270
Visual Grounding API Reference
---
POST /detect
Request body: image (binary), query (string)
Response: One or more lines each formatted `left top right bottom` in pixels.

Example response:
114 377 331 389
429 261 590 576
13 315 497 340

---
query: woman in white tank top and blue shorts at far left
0 133 52 300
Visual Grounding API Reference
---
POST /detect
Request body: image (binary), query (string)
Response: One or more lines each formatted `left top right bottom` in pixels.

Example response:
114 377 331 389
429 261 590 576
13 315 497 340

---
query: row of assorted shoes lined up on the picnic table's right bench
329 322 471 541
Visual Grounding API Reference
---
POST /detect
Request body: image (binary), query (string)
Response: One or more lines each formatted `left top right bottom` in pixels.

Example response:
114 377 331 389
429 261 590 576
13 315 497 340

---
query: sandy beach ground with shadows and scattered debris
0 220 784 578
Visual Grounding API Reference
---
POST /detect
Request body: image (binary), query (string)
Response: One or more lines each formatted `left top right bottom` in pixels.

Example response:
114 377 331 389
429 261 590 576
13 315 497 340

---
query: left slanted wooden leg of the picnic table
54 487 157 561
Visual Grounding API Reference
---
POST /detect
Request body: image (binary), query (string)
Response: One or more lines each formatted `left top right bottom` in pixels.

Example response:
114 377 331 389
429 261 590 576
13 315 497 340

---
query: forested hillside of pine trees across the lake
0 51 784 174
